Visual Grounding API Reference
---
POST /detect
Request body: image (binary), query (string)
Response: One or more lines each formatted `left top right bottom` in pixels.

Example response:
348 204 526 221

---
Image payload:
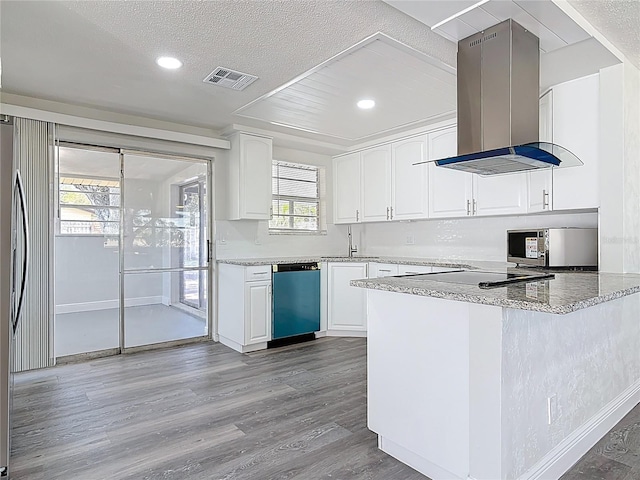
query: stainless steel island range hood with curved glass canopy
424 19 582 175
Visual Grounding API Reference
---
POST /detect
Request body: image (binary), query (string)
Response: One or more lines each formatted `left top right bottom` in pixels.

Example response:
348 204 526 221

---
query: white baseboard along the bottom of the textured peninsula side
518 379 640 480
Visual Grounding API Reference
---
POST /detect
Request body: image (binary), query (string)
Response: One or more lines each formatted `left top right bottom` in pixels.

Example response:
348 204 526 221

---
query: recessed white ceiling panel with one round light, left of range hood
234 33 456 142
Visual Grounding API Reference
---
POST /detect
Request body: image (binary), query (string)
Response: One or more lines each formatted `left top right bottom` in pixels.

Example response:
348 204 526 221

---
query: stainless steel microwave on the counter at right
507 228 598 268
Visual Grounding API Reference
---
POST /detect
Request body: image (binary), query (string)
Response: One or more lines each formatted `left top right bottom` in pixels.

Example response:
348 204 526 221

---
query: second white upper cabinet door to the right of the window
360 145 391 222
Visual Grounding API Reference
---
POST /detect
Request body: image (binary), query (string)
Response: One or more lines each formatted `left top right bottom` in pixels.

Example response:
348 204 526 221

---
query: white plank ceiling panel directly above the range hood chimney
385 0 589 52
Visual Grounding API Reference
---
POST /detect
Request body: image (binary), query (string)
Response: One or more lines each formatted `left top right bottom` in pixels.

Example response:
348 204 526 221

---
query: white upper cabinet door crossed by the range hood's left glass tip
427 127 473 218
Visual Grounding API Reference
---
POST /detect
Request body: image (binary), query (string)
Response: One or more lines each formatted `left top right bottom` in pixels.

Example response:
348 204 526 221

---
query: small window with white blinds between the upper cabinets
269 161 320 232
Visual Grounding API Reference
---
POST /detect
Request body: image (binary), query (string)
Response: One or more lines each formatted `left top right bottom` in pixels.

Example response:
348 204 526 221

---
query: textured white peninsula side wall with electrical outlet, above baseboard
502 294 640 478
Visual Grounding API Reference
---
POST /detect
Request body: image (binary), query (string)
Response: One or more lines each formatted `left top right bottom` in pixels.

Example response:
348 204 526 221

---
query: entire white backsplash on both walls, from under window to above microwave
216 212 598 262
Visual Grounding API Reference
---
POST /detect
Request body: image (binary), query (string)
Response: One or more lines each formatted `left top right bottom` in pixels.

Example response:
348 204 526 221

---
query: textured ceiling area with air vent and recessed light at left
0 0 456 145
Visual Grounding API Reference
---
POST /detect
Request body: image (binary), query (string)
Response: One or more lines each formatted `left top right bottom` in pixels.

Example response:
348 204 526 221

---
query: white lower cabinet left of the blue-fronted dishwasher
218 264 271 353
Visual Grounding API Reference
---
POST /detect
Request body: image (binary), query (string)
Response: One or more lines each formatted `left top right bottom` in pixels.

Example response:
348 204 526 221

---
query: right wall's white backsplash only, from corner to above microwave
353 212 598 262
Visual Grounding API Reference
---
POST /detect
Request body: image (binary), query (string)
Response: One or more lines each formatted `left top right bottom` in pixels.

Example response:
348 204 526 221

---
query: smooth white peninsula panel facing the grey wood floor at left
367 290 484 480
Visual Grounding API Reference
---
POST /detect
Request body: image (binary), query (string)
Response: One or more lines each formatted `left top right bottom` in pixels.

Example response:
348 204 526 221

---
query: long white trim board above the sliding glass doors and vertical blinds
0 103 231 150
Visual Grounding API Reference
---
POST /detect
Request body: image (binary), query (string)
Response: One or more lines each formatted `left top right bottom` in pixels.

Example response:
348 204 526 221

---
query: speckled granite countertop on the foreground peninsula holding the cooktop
351 270 640 314
